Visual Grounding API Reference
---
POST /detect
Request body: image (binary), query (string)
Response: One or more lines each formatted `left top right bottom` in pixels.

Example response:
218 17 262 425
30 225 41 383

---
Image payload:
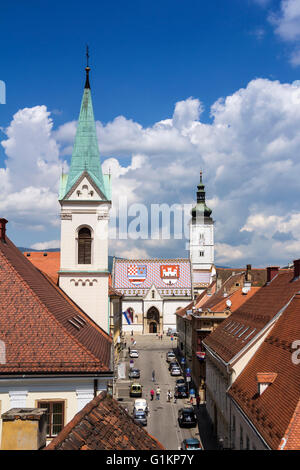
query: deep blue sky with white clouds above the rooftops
0 0 300 267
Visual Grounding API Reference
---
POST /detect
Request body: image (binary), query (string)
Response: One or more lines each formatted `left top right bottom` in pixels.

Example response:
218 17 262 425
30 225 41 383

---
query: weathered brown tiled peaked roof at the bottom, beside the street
45 392 165 450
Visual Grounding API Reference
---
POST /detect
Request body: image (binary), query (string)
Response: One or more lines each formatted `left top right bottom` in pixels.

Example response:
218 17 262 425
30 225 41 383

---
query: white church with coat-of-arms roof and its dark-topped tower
112 173 216 334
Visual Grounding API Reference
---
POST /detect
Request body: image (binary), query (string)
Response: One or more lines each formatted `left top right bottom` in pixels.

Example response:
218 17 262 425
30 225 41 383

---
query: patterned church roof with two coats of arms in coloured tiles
113 259 191 295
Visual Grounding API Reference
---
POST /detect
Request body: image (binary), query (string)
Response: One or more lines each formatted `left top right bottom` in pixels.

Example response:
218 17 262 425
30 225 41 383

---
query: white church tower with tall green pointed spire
59 54 111 332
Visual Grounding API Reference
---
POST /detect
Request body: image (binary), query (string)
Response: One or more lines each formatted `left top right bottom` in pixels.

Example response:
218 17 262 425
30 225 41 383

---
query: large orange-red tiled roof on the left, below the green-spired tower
0 239 112 374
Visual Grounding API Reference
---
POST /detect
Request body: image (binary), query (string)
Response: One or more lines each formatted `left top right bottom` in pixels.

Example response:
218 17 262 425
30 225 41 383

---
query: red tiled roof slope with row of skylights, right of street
203 270 300 362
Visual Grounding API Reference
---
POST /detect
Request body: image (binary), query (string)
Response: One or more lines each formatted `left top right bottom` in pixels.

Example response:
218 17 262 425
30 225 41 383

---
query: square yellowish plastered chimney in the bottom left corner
1 408 47 450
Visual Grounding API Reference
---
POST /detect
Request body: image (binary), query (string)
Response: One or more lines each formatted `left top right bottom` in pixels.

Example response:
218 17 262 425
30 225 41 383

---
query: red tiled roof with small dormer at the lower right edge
229 294 300 450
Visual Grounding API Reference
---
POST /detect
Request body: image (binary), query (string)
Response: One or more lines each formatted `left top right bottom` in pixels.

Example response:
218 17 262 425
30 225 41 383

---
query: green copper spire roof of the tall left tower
59 67 110 200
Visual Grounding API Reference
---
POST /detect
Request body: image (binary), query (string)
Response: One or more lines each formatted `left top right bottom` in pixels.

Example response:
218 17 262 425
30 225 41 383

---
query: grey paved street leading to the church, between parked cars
116 335 209 450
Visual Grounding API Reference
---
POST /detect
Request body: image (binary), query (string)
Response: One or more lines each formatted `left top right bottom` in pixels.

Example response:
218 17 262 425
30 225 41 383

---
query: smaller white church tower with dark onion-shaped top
190 171 216 292
